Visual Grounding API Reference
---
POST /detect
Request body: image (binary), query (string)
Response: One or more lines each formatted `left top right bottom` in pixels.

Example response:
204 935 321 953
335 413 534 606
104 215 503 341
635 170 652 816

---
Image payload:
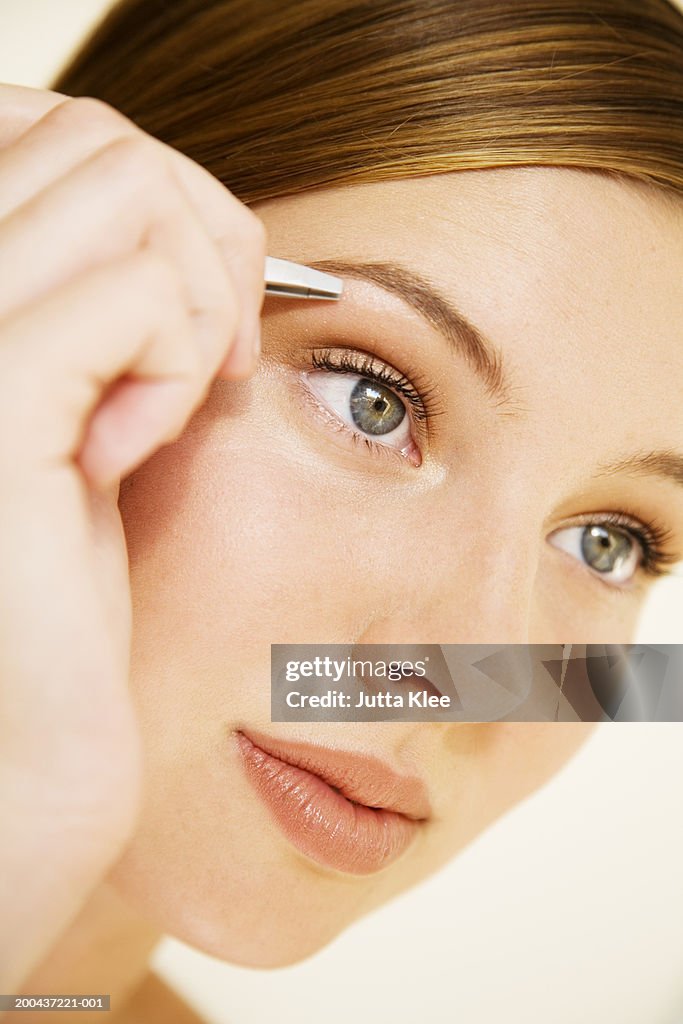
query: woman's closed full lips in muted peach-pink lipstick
236 731 430 874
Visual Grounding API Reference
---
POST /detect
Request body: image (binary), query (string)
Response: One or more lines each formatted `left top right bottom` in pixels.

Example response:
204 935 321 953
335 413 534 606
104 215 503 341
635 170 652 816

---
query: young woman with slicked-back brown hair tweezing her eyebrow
0 0 683 1022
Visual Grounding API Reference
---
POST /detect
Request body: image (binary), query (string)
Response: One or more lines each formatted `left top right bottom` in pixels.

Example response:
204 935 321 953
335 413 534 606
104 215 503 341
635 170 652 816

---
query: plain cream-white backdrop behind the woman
0 0 683 1024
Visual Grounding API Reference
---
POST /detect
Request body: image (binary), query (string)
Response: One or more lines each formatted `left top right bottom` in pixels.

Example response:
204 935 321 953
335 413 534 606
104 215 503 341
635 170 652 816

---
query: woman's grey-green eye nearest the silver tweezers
305 364 420 465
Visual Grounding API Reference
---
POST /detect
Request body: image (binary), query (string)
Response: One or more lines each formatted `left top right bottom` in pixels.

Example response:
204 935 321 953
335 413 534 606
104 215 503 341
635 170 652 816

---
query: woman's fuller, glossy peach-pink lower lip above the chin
238 733 420 874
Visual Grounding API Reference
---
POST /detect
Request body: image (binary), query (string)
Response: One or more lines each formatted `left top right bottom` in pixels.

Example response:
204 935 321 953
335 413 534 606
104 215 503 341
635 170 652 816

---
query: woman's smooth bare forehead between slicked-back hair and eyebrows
256 167 683 444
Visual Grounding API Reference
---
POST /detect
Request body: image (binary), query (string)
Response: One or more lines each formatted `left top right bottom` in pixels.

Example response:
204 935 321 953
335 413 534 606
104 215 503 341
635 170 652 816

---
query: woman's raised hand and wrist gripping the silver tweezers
0 86 266 991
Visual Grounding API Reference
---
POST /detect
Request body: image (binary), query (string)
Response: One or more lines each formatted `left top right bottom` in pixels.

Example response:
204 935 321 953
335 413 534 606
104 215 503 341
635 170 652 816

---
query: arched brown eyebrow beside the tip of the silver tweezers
306 259 510 406
